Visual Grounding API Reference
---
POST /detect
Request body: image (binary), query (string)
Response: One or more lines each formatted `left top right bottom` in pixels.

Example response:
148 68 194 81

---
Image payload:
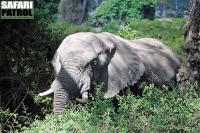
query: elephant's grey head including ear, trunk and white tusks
39 33 144 114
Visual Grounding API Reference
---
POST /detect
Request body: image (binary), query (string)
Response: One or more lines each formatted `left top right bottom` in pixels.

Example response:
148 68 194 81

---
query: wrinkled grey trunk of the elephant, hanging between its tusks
52 69 79 115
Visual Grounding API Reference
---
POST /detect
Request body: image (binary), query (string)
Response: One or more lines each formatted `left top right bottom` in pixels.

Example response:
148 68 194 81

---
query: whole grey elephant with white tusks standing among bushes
39 32 180 115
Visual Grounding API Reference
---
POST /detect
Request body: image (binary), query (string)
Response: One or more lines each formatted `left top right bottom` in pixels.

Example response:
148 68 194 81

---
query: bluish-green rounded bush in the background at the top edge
92 0 156 22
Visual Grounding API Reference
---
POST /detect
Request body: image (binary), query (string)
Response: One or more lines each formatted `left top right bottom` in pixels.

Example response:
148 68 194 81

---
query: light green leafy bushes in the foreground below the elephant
19 84 200 133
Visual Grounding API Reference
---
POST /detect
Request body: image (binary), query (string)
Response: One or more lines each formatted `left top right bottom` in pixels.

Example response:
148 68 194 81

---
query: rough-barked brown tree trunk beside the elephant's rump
177 0 200 91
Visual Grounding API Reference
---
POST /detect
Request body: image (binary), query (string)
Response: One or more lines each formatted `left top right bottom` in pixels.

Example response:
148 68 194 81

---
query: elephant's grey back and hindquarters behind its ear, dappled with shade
131 38 180 85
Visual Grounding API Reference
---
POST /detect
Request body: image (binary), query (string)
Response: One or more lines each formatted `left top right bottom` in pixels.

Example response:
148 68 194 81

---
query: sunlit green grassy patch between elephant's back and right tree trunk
122 19 185 57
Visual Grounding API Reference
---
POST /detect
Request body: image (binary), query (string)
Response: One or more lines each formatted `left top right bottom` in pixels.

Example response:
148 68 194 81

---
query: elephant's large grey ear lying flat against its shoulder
99 33 145 98
